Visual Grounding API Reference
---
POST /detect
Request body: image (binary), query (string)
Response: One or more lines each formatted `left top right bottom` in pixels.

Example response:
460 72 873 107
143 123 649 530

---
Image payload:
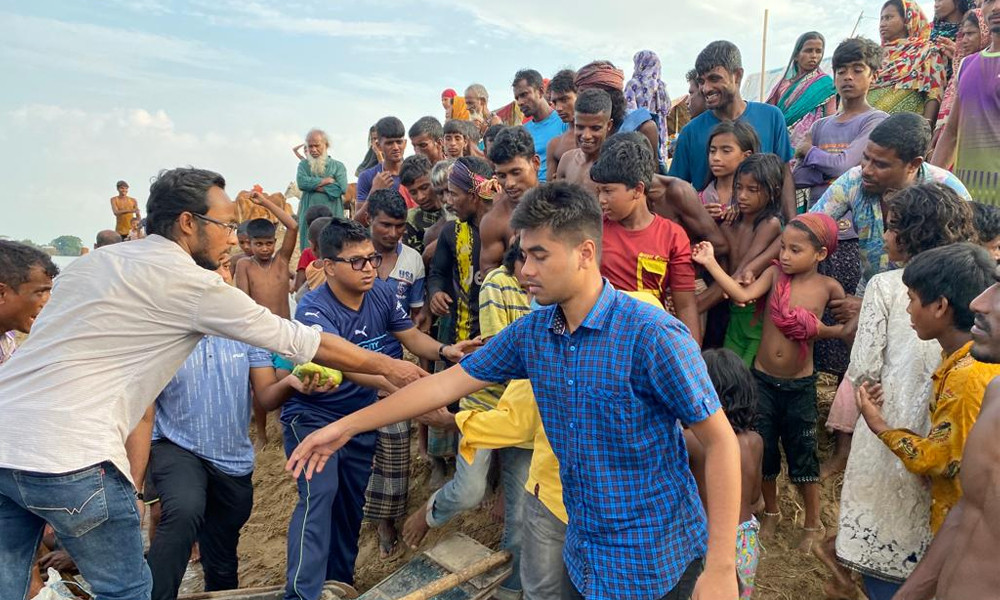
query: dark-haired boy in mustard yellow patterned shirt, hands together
857 243 1000 534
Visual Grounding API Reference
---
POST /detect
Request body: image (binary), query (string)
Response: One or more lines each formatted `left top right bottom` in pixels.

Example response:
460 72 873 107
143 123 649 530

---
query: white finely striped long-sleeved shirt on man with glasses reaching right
0 235 320 477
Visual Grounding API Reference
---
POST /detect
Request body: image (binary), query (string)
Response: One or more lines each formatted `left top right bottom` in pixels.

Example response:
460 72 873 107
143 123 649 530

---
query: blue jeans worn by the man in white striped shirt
0 462 153 600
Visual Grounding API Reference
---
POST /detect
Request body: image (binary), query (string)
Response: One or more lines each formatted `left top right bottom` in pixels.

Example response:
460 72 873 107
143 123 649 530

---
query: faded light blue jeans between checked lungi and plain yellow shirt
427 448 532 590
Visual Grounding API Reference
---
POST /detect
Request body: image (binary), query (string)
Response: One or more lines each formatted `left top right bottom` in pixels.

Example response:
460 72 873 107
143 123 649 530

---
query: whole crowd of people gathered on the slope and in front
0 0 1000 600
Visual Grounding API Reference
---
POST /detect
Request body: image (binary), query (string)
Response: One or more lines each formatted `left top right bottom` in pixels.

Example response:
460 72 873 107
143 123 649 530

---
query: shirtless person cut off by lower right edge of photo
894 268 1000 600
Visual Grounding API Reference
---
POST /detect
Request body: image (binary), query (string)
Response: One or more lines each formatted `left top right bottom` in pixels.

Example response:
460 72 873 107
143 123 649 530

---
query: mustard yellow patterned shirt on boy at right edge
878 342 1000 533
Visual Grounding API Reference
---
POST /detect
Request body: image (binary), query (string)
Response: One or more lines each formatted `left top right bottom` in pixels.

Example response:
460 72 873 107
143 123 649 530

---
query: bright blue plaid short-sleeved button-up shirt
461 282 719 600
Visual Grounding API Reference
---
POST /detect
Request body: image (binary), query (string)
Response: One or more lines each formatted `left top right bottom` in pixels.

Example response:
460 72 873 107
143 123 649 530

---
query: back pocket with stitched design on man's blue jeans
14 465 108 537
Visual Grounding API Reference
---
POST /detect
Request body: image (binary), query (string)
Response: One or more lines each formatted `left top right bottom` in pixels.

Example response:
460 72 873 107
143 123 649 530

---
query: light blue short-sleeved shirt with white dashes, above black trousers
153 335 271 477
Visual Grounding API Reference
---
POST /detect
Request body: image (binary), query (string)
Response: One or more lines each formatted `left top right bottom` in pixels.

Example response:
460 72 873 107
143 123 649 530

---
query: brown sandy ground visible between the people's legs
229 379 841 600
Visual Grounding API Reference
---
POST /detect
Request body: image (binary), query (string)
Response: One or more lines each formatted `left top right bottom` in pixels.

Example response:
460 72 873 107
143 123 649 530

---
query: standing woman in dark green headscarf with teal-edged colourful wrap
767 31 837 148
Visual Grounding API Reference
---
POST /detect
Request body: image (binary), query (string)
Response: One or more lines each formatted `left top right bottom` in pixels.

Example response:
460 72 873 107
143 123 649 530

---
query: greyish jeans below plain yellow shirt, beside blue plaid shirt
521 492 569 600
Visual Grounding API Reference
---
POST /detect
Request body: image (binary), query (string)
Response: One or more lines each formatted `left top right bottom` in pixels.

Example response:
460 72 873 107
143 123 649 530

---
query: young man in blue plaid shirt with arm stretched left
289 182 740 600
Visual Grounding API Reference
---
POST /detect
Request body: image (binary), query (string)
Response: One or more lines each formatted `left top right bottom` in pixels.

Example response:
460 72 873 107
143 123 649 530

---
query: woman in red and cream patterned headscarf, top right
868 0 948 126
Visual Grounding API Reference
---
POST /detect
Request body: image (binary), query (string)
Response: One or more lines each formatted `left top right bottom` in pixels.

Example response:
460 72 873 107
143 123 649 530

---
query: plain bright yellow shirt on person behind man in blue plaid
455 288 663 523
